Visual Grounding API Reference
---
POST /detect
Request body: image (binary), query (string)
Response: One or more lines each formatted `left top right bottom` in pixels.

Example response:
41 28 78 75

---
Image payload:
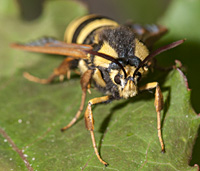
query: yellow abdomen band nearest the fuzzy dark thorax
77 18 118 44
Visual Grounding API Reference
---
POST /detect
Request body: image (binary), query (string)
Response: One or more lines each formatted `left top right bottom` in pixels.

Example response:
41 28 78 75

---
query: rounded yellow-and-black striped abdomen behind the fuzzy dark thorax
64 14 118 44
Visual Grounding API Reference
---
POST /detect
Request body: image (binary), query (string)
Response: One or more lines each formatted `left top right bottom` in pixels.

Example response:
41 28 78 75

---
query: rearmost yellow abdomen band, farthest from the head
64 14 96 43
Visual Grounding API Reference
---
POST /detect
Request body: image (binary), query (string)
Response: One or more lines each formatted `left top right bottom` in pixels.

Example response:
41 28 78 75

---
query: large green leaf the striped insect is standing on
0 1 200 171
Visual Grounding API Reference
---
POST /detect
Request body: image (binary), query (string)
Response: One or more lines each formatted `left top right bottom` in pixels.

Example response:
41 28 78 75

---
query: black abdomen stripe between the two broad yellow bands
72 16 109 43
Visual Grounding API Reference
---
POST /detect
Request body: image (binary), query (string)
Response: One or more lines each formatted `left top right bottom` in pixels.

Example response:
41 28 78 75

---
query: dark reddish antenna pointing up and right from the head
133 39 185 77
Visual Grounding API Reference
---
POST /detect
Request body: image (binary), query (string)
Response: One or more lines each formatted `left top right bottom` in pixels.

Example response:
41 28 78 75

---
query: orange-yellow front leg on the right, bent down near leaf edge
139 82 165 152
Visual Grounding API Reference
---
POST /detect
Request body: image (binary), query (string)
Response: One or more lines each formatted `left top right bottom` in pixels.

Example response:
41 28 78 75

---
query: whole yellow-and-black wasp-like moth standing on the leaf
12 14 184 166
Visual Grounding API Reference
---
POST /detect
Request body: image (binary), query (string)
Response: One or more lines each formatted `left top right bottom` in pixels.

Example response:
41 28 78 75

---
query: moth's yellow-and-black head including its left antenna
86 48 146 99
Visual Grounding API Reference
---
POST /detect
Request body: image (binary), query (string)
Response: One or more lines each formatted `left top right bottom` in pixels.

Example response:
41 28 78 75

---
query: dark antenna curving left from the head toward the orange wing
86 50 127 78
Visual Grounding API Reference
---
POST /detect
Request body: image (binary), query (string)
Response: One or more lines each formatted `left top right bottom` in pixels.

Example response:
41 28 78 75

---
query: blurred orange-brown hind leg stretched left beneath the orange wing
24 57 75 84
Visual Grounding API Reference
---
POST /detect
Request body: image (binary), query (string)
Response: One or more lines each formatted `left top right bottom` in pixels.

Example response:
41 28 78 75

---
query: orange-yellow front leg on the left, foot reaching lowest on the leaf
85 96 110 166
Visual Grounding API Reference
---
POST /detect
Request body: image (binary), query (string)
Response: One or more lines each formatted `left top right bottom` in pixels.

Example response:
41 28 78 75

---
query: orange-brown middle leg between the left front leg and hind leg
61 70 93 131
